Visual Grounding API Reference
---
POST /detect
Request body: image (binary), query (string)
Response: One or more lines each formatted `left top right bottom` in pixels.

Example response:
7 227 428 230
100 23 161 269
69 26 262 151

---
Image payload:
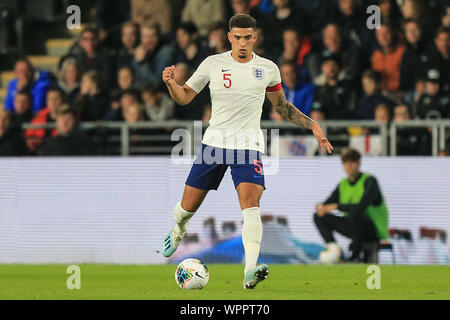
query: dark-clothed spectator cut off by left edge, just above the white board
0 110 27 157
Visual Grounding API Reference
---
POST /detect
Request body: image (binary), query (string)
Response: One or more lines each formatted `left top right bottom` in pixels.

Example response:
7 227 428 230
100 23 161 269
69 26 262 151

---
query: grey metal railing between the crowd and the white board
23 119 450 156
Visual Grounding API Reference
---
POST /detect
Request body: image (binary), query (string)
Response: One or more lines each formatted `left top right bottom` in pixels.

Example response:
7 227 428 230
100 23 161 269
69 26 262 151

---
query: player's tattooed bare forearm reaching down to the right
267 90 333 153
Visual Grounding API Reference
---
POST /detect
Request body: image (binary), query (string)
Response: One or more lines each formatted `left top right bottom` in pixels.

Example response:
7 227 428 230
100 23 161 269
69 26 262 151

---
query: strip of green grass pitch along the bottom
0 264 450 300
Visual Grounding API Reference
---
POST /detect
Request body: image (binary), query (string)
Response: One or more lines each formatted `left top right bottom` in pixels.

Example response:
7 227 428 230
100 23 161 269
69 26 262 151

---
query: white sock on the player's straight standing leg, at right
242 207 262 274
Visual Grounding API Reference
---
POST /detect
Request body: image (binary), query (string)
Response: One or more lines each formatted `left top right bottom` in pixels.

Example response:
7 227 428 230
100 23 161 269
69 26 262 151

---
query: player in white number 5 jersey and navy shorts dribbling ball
162 14 333 289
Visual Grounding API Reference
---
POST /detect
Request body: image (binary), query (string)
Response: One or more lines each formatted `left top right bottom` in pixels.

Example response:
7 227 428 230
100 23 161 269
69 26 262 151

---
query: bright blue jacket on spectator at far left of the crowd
5 70 51 113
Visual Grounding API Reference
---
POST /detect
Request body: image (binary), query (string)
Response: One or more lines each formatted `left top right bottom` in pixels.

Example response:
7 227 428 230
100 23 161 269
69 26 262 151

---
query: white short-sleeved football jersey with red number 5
186 51 281 152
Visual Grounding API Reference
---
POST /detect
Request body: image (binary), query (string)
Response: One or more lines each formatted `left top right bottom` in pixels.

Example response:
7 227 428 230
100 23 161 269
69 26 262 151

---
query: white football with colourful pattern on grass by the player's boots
175 259 209 289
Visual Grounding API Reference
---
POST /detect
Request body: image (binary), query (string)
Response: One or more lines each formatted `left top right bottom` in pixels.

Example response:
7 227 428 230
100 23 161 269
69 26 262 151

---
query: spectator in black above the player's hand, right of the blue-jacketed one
314 56 356 120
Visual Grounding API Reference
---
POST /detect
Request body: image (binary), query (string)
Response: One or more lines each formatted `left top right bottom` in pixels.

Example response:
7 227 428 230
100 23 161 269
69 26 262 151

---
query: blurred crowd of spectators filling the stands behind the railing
0 0 450 155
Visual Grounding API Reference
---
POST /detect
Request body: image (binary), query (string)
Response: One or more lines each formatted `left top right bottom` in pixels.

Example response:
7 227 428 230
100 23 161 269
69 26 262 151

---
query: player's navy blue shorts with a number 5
186 144 265 190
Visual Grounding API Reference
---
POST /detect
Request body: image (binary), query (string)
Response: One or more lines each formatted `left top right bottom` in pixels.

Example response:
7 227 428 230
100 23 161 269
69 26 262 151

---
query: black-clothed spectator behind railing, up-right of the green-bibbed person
393 104 431 156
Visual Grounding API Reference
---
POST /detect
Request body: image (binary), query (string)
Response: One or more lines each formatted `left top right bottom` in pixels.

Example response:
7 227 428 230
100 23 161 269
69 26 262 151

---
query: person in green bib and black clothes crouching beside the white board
314 148 389 263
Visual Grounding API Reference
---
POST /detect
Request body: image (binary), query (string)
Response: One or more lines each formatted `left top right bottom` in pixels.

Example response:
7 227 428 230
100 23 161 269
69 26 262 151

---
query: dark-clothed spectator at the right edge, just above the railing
416 69 450 119
